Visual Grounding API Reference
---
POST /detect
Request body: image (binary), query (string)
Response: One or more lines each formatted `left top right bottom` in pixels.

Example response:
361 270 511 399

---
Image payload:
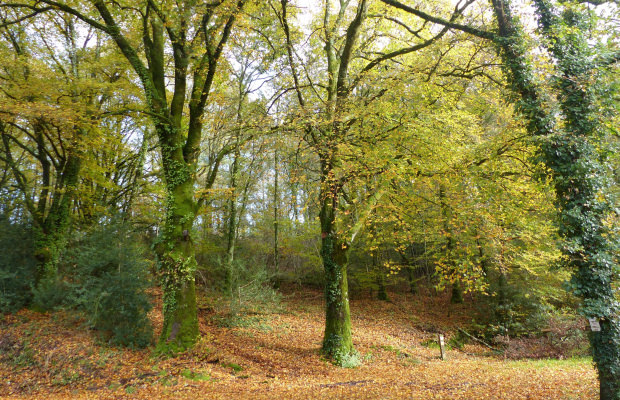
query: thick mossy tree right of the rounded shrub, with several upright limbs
0 0 252 352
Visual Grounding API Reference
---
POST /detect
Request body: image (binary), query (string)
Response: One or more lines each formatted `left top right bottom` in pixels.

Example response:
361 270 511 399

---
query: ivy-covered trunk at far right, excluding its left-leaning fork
534 0 620 400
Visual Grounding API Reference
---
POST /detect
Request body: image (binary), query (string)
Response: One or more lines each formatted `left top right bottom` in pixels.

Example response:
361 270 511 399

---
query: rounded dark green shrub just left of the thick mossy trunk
59 224 153 347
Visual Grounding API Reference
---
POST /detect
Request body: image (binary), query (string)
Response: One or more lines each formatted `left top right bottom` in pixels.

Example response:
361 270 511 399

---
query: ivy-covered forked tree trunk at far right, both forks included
492 0 620 400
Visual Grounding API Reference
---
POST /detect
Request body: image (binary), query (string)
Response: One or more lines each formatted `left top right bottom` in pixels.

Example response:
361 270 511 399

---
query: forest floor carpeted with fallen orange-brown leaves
0 289 598 400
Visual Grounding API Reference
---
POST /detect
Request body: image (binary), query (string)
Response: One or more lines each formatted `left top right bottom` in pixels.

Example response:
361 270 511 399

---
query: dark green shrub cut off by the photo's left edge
0 216 37 313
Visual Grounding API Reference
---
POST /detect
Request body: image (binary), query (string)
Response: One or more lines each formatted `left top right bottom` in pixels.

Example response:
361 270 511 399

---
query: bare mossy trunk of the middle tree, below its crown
319 163 354 365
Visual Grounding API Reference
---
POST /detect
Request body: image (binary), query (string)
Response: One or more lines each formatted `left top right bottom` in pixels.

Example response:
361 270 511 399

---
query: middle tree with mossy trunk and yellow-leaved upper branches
272 0 478 364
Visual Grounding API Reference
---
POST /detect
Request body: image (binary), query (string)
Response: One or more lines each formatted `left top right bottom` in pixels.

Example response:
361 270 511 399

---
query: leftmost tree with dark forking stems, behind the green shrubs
0 12 129 286
